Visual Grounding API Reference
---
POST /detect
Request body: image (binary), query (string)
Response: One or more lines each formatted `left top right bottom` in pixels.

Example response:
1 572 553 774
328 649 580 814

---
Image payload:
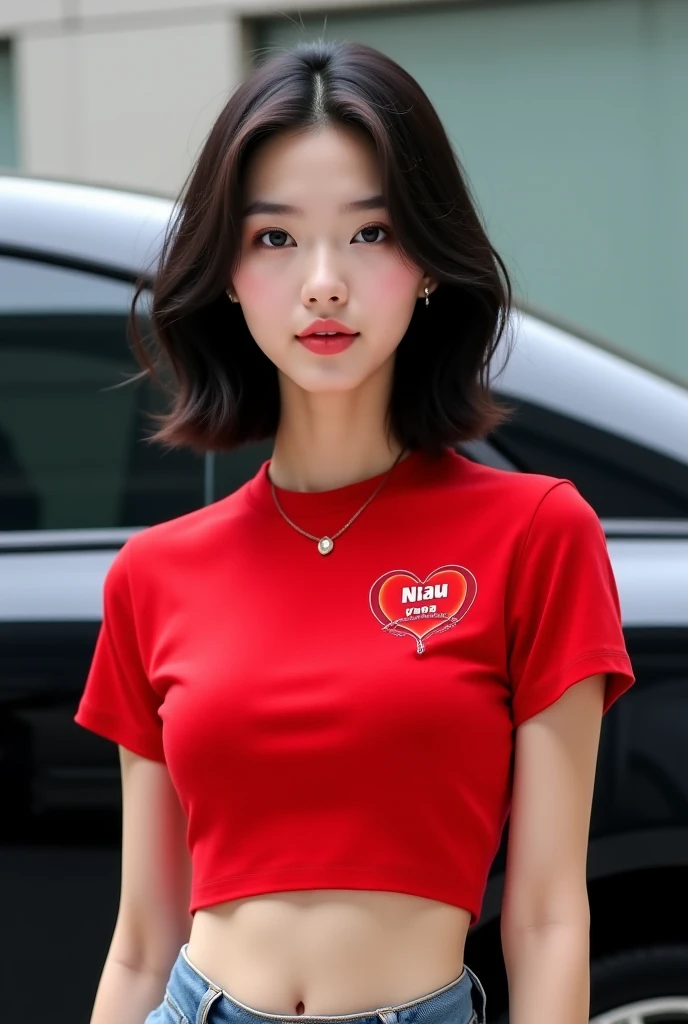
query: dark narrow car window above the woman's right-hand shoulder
493 395 688 519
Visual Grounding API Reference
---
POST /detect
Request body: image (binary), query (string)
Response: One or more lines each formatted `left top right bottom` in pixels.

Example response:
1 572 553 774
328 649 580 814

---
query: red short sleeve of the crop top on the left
74 542 165 762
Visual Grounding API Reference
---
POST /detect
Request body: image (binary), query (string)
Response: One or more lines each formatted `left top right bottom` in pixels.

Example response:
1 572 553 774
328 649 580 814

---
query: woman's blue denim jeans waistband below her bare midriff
144 944 485 1024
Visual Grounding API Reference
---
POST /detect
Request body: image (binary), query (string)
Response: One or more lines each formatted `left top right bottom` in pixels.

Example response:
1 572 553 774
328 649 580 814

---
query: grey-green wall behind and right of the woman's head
256 0 688 381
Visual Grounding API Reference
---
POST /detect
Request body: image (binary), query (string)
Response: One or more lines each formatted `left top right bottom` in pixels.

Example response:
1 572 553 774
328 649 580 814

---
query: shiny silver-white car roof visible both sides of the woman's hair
0 174 688 463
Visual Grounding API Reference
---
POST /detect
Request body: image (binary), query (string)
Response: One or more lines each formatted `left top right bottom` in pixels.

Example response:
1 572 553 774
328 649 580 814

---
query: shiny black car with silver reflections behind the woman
0 173 688 1024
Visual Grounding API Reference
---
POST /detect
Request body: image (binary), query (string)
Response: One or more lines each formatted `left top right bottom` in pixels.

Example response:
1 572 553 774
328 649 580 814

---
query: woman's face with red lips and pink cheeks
228 127 429 392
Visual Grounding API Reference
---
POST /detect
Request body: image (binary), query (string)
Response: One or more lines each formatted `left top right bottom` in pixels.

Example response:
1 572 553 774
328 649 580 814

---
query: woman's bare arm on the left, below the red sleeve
90 745 192 1024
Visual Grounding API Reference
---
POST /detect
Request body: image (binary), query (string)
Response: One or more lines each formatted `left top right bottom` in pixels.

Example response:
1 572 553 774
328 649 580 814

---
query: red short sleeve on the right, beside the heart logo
507 480 635 726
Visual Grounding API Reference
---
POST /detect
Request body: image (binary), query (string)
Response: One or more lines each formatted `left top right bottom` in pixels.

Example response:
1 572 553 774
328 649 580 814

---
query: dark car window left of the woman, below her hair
0 256 204 530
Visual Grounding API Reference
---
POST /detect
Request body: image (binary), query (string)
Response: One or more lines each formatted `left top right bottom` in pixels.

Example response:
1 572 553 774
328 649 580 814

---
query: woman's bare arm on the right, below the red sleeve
502 675 606 1024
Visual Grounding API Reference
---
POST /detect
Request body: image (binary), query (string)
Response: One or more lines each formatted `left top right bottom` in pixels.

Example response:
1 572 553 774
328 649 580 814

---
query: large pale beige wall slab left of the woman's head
16 14 247 193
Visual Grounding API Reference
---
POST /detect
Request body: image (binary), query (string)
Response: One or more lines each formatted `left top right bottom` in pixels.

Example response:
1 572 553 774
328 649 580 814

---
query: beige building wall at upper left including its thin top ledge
5 0 436 194
